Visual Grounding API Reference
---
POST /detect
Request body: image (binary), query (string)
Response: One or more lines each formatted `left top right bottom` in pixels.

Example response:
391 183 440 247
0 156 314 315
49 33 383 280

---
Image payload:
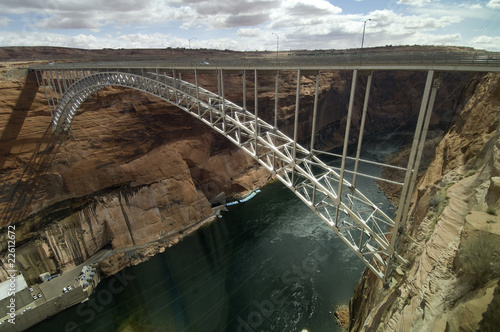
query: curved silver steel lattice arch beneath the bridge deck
52 71 394 278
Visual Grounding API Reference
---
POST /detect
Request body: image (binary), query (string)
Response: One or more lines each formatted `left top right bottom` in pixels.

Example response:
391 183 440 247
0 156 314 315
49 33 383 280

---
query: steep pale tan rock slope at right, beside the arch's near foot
350 74 500 331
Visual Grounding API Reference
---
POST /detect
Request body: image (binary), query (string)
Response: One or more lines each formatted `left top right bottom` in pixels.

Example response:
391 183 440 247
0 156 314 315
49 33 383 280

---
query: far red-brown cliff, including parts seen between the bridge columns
0 52 476 282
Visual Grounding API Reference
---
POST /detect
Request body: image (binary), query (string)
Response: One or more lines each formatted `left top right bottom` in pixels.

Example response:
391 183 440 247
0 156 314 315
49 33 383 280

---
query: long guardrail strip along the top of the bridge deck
30 52 500 71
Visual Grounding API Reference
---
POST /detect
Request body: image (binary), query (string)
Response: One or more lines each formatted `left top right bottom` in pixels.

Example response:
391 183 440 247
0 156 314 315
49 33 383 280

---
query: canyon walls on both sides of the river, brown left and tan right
0 49 500 331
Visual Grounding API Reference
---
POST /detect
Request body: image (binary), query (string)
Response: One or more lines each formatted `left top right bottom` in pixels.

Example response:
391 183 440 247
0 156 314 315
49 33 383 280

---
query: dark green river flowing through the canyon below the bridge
25 131 404 332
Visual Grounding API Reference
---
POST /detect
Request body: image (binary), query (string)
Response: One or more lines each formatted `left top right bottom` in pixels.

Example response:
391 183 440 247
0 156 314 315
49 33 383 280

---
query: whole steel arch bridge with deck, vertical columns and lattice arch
32 54 498 279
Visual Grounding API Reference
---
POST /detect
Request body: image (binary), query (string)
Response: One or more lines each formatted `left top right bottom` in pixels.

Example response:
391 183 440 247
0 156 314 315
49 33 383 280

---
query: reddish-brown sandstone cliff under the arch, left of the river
0 65 270 282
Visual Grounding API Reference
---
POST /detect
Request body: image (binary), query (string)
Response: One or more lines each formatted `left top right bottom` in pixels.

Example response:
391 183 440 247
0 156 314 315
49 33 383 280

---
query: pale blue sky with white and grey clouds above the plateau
0 0 500 51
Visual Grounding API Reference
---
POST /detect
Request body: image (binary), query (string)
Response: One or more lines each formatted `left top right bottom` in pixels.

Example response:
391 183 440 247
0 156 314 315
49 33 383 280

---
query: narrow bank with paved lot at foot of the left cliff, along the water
5 202 230 332
